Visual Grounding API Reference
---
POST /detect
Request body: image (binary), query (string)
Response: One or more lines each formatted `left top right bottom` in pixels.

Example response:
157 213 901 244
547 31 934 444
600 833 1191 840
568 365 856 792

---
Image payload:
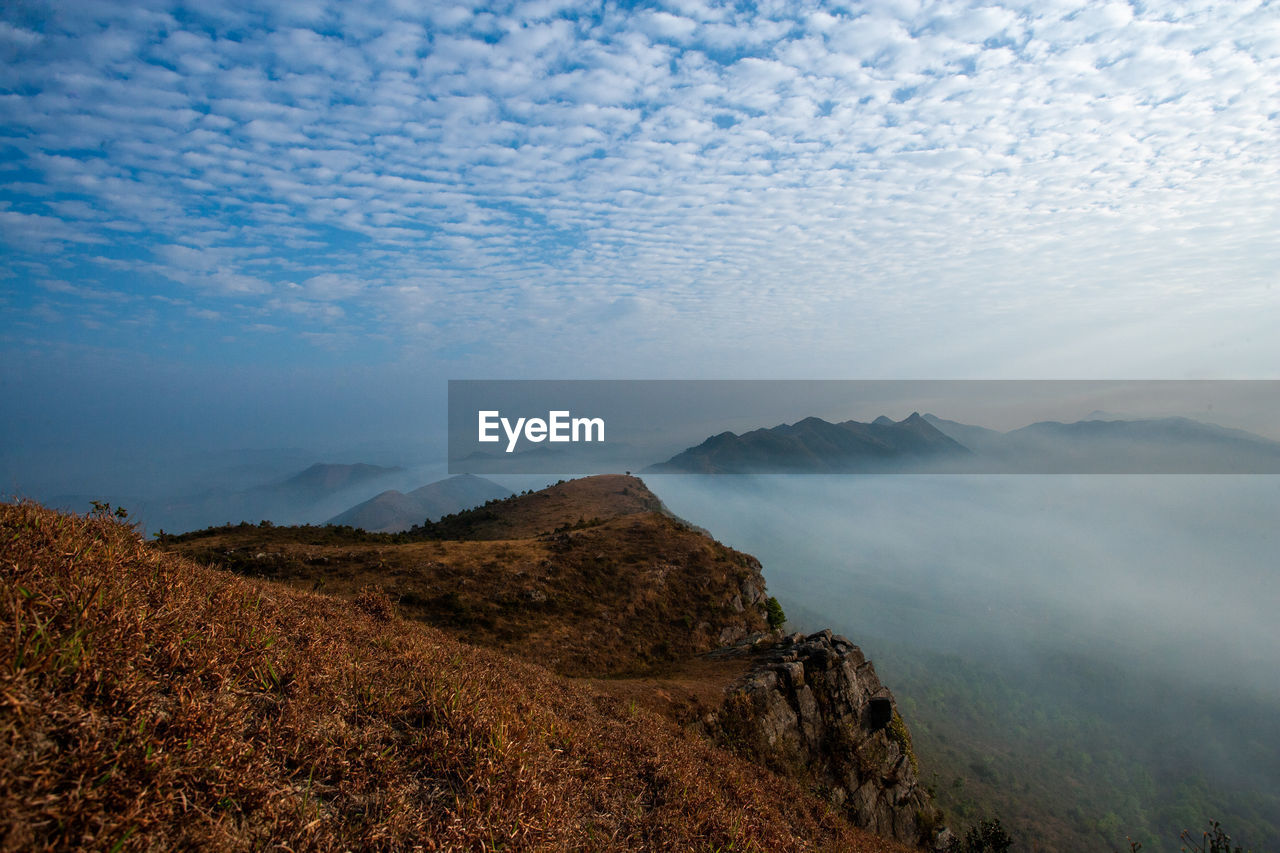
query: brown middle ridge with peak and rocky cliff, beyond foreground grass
161 475 940 849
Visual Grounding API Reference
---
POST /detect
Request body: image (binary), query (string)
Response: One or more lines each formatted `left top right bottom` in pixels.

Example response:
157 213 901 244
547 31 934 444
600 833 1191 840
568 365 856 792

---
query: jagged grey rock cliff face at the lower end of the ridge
716 630 940 845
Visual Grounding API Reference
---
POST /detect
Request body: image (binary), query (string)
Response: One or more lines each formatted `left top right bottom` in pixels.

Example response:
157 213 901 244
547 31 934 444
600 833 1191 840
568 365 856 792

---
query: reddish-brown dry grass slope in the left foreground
0 503 902 850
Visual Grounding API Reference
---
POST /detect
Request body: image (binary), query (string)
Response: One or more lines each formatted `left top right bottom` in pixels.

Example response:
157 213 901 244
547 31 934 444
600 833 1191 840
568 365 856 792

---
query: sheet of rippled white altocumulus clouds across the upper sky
0 0 1280 370
